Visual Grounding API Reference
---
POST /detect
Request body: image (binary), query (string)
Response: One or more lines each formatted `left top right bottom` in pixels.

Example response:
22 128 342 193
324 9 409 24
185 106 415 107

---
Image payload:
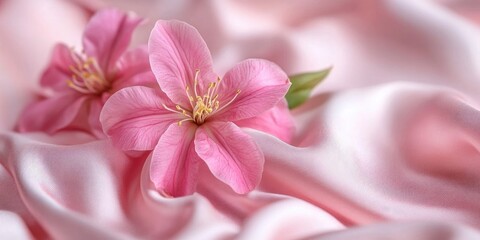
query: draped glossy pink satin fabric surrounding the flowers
0 0 480 240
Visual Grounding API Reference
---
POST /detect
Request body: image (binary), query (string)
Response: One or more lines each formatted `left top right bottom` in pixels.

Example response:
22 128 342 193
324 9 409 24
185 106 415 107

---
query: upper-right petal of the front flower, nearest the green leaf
213 59 290 121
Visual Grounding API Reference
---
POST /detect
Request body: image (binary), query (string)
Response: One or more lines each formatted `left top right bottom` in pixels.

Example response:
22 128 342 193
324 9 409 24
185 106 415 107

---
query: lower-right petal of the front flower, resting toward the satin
195 122 265 194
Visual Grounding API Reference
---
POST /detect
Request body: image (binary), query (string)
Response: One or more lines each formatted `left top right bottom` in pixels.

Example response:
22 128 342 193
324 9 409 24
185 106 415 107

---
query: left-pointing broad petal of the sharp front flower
100 86 181 150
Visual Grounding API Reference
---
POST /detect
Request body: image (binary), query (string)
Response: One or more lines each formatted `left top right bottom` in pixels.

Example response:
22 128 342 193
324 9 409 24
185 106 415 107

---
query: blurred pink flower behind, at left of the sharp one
18 9 154 137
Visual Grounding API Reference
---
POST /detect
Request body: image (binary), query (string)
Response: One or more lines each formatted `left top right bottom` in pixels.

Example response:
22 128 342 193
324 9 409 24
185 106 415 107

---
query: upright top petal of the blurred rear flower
83 9 142 74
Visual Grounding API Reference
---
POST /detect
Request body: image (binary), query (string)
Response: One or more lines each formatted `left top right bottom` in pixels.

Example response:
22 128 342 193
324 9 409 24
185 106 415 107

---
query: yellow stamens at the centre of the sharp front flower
163 70 240 126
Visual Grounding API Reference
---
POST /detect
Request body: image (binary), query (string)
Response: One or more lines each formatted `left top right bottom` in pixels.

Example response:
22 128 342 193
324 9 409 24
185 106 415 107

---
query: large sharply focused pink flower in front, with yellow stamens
100 21 292 196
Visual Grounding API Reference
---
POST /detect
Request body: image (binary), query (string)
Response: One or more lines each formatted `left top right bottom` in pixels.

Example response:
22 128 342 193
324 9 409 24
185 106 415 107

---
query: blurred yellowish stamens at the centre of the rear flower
67 50 111 94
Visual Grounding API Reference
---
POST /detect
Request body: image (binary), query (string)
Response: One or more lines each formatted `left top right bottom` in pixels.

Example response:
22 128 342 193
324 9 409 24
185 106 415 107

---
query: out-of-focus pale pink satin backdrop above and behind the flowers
0 0 480 129
